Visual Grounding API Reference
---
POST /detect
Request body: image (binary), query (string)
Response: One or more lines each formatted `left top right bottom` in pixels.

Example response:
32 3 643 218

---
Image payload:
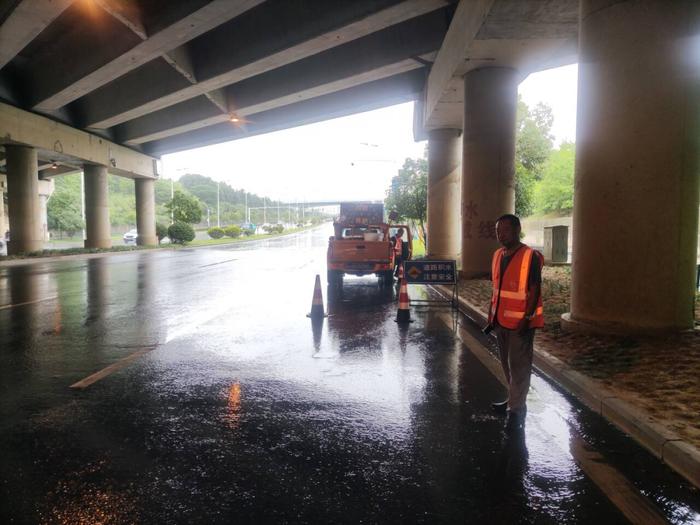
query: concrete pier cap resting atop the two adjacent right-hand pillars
422 0 578 130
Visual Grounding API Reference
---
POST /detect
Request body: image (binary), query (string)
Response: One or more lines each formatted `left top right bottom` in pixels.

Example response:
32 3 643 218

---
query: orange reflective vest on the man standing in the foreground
489 246 544 330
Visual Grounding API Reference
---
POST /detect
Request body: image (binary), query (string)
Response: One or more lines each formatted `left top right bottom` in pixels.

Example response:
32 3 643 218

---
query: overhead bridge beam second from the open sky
114 11 447 144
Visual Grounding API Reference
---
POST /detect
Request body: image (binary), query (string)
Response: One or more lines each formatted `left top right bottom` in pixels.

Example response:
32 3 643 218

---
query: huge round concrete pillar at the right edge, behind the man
562 0 700 334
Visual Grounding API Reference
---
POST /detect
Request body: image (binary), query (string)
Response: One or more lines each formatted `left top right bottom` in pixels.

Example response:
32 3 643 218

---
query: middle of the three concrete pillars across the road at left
83 164 112 248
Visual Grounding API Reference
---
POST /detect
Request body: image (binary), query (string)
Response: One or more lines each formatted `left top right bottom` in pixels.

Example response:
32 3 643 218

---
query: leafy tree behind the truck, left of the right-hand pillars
384 156 428 238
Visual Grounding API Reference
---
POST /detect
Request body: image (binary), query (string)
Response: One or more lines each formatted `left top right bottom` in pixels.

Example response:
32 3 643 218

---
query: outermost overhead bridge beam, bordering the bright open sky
144 70 425 155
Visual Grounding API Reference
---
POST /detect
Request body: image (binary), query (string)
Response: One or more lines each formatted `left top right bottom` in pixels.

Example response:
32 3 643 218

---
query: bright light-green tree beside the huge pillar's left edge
535 142 576 214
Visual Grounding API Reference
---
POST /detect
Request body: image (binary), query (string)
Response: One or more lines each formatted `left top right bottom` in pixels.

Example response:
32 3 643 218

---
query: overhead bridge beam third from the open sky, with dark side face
76 0 448 128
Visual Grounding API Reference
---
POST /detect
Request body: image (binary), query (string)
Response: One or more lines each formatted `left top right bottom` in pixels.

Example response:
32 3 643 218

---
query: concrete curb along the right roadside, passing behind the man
435 285 700 488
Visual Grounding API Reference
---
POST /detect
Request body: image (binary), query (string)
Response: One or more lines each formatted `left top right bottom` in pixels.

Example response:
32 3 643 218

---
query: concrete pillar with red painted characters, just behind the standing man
460 67 518 278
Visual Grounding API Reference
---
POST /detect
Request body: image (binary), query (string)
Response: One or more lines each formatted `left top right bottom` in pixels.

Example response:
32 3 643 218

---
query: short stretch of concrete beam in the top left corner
0 0 73 69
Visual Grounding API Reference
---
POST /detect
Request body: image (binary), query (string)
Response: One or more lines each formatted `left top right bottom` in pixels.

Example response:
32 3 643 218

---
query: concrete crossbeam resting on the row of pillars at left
0 103 158 178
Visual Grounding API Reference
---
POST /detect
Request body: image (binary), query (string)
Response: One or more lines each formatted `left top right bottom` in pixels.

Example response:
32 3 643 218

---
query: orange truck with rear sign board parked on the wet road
327 202 413 287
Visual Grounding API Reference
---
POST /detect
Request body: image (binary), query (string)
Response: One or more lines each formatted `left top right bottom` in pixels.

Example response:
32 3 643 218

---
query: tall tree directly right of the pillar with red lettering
515 95 554 217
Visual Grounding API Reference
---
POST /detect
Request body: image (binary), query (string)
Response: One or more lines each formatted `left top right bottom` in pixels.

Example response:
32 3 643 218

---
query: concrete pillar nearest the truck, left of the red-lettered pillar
427 129 462 262
